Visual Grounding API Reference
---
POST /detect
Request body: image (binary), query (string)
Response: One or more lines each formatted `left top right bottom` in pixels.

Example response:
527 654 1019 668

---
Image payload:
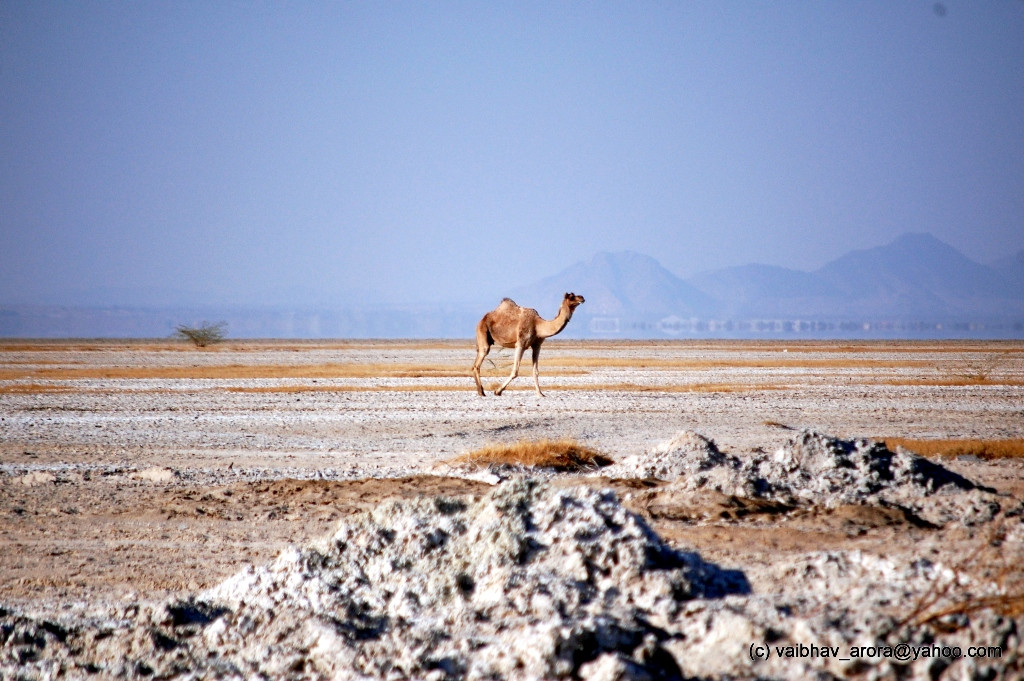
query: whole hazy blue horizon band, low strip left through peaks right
6 233 1024 338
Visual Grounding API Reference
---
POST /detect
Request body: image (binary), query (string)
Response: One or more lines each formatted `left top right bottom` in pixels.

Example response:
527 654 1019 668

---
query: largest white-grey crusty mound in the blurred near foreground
0 480 749 679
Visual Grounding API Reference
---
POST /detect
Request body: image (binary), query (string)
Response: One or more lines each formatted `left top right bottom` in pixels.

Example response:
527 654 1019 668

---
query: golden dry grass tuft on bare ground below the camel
447 438 614 472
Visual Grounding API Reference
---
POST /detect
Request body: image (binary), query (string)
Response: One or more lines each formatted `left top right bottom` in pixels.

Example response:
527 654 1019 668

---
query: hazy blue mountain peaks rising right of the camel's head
512 233 1024 337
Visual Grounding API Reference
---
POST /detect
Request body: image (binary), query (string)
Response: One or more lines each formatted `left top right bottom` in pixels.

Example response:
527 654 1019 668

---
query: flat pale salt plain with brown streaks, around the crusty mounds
0 340 1024 675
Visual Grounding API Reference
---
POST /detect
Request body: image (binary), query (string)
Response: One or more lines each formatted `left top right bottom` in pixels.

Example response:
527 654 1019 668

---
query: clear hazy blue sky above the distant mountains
0 0 1024 304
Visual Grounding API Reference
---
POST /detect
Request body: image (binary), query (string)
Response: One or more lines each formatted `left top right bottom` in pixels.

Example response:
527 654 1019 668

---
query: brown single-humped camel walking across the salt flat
473 293 584 397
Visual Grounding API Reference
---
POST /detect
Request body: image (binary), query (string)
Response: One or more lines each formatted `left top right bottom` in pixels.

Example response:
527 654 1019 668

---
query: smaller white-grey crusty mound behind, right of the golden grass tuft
602 430 999 525
